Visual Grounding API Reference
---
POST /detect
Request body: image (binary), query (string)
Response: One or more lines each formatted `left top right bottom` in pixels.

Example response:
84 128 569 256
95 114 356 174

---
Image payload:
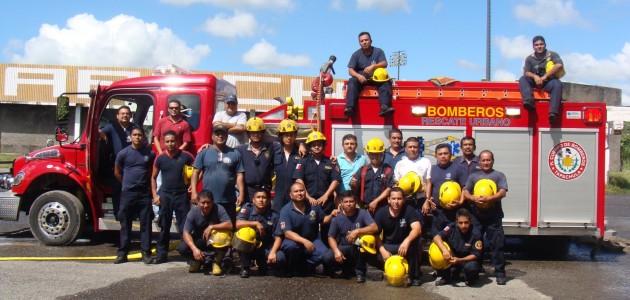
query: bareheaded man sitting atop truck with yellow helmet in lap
344 32 394 118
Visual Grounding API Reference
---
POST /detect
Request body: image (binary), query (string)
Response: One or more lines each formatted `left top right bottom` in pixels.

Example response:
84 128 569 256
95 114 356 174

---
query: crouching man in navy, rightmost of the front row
433 208 483 286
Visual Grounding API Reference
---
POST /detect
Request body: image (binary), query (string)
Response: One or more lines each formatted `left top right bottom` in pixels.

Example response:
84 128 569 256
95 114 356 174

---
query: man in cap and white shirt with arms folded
212 94 247 148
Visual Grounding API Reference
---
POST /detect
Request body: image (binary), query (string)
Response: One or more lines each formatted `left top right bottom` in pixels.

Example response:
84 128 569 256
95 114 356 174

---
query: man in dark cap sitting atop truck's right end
518 35 564 125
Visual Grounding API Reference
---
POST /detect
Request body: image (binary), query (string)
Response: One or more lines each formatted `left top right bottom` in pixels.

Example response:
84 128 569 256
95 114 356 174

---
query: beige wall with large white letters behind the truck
0 64 346 110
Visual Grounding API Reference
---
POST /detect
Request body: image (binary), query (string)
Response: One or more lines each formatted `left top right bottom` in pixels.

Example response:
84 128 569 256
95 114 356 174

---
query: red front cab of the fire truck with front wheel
0 68 236 245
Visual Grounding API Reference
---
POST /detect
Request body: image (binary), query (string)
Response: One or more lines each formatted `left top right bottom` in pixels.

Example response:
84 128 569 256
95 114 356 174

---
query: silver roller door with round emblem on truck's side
538 130 599 228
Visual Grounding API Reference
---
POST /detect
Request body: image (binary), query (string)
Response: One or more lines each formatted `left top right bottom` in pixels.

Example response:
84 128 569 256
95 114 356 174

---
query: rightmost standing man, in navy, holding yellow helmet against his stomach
463 150 508 285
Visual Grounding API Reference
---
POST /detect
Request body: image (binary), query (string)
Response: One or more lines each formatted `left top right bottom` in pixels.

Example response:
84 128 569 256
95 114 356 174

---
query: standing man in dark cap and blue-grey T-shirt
190 124 246 223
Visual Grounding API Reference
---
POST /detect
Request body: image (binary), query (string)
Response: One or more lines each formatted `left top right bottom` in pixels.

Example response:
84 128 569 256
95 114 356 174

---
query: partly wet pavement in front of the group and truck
0 195 630 299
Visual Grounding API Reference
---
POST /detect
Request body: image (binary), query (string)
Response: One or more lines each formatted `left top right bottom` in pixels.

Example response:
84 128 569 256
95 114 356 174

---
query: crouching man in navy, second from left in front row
235 188 282 278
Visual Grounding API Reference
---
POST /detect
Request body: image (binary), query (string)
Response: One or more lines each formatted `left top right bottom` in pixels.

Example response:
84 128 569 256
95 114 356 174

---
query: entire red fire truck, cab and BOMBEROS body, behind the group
0 68 606 245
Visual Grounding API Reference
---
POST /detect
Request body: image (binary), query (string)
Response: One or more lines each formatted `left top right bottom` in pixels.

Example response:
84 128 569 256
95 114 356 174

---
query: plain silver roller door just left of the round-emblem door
474 128 532 227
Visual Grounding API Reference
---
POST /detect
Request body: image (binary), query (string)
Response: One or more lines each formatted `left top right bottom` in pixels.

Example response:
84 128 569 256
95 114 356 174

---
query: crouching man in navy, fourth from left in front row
323 190 378 283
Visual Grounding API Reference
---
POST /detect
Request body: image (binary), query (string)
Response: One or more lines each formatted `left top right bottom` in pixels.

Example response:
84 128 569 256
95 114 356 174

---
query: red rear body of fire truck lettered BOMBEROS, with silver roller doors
268 81 606 237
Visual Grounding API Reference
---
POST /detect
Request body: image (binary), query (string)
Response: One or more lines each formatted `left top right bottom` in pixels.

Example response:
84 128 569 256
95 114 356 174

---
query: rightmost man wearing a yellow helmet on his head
350 138 394 215
